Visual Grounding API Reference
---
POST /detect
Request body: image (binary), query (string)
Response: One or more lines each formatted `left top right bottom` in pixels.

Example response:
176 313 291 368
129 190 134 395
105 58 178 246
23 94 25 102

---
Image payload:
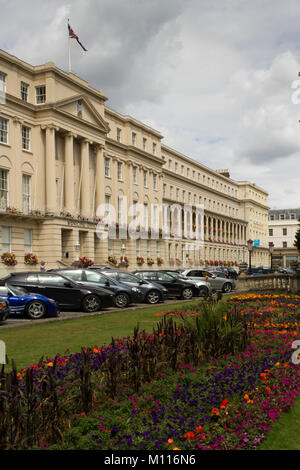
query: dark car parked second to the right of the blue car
56 269 143 308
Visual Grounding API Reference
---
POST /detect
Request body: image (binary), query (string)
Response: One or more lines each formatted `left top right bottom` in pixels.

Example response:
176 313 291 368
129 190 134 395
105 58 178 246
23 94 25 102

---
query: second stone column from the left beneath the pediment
64 132 76 215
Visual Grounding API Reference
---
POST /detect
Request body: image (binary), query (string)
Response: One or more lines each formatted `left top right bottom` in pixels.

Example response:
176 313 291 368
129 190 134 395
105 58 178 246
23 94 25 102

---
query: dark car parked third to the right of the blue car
100 269 168 304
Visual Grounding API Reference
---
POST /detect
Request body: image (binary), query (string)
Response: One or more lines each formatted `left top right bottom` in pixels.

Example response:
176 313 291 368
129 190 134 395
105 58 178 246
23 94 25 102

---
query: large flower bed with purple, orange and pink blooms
0 294 300 450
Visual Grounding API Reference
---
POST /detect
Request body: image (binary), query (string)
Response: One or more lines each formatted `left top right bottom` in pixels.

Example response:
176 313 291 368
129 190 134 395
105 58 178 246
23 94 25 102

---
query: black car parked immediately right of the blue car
0 272 114 312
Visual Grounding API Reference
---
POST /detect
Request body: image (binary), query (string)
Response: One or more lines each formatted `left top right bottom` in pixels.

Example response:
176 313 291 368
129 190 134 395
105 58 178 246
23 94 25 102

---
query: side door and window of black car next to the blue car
38 273 82 309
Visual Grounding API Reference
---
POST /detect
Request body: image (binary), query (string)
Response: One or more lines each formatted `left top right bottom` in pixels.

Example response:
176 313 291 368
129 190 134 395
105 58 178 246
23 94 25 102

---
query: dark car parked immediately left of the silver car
133 271 197 300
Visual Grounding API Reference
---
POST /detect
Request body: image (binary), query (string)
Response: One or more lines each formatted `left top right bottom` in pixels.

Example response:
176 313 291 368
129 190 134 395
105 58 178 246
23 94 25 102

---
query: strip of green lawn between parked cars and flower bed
0 300 199 369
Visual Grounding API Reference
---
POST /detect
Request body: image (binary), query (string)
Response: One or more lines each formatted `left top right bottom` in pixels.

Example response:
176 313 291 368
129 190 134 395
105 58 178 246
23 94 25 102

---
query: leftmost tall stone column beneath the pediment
45 126 57 214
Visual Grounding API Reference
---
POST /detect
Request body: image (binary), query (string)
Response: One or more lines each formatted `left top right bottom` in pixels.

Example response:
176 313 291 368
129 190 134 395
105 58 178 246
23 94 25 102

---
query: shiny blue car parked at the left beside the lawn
0 285 60 320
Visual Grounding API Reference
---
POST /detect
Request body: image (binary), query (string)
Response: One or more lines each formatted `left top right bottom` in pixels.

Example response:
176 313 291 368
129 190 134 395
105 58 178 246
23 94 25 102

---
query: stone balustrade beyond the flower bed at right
236 273 300 294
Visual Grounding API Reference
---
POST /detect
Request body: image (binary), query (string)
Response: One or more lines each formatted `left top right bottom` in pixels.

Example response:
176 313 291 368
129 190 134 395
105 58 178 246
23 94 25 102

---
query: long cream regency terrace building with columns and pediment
0 51 269 274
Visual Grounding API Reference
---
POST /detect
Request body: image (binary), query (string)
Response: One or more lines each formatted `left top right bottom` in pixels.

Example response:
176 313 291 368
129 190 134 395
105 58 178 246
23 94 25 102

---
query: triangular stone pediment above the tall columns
54 95 110 133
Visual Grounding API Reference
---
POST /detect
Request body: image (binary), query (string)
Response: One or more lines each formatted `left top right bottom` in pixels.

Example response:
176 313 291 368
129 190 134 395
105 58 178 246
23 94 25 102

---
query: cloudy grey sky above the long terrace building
0 0 300 208
